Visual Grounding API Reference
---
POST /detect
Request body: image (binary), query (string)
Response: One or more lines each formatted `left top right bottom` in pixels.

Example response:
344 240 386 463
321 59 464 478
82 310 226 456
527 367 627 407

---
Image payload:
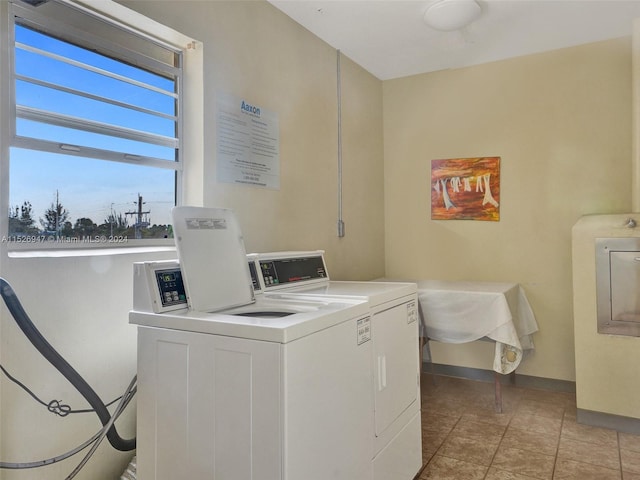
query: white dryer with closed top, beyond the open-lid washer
254 251 422 480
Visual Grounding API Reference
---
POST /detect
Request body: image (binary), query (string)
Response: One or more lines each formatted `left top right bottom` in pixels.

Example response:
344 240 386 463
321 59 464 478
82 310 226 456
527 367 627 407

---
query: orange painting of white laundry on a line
431 157 500 222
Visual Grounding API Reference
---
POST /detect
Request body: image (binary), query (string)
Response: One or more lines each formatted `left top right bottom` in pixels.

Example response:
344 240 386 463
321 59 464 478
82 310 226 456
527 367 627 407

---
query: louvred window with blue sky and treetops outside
6 0 183 247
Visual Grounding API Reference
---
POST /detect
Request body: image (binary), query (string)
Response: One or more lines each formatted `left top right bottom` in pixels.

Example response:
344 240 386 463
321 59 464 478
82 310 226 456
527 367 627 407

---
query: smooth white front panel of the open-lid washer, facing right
283 319 374 480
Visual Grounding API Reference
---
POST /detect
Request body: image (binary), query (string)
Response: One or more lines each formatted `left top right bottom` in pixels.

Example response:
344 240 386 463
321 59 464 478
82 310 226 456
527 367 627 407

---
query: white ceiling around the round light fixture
269 0 640 80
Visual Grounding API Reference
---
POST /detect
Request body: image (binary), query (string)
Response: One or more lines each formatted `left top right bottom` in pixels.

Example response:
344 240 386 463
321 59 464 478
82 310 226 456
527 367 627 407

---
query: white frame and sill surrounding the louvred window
0 0 203 256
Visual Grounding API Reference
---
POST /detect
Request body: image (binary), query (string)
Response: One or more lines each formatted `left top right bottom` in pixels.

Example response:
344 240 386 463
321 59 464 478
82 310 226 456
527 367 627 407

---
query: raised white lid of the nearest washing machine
171 207 255 312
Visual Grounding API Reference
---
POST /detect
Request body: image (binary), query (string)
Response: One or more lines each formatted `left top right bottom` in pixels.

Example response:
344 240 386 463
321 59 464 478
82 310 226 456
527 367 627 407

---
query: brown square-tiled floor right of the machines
419 374 640 480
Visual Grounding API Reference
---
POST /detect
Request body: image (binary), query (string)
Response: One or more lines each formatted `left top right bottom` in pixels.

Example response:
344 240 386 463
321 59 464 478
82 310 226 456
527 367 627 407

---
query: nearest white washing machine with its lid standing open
129 207 374 480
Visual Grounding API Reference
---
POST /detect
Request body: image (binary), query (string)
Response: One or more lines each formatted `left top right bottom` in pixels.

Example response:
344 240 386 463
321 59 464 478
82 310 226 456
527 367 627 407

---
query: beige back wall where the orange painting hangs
383 38 631 380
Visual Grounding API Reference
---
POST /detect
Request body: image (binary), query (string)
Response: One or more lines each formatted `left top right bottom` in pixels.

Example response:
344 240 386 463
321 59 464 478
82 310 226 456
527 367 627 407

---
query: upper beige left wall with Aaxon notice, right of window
122 0 384 279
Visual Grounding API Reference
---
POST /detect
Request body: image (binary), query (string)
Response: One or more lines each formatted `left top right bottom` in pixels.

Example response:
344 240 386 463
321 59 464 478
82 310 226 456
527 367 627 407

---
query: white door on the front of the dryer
372 303 418 436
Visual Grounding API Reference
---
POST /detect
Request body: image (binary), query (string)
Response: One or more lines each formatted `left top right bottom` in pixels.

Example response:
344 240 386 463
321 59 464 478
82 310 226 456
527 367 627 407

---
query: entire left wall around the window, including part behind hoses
0 0 384 480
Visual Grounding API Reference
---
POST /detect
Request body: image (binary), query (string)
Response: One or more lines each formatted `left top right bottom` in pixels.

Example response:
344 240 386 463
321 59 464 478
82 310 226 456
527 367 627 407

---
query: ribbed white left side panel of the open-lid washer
137 327 282 480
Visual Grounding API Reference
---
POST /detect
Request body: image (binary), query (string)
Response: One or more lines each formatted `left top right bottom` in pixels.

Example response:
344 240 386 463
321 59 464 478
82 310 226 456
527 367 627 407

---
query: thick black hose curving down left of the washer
0 278 136 452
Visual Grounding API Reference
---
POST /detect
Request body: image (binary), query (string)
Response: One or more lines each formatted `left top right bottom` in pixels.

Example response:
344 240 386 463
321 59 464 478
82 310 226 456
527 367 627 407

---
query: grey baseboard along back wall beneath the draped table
422 362 576 393
